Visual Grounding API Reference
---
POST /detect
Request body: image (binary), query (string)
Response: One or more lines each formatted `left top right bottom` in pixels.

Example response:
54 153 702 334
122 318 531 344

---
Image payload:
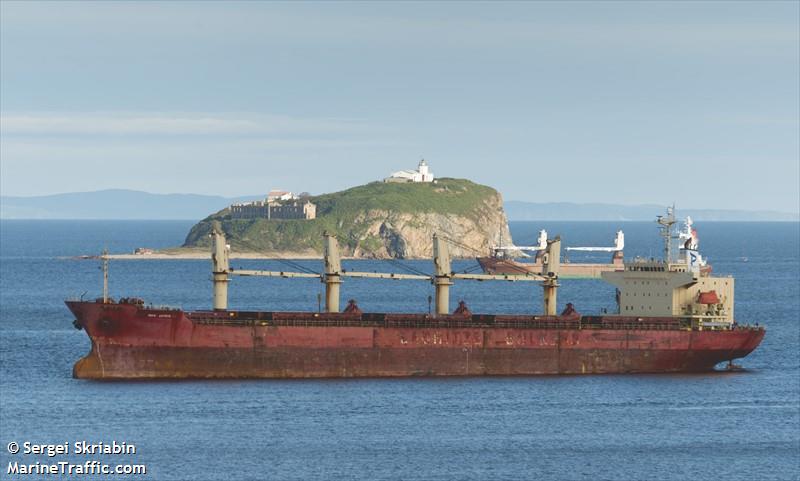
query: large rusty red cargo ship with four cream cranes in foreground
66 210 765 379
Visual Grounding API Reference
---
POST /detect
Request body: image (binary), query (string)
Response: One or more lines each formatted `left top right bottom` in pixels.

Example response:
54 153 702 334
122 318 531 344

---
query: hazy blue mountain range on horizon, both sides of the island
0 189 800 221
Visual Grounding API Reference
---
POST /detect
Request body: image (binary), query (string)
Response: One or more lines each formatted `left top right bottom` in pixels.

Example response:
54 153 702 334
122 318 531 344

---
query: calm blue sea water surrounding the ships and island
0 221 800 480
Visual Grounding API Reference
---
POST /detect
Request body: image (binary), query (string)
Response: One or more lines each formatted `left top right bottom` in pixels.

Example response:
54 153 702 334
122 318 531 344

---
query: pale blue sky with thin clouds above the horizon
0 0 800 212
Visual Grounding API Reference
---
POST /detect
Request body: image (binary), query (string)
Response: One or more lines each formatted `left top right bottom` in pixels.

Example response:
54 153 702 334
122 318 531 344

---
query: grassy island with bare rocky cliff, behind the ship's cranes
184 179 511 258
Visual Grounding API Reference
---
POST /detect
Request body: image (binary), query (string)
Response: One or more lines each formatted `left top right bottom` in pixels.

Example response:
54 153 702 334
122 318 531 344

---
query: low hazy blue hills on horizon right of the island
504 200 800 222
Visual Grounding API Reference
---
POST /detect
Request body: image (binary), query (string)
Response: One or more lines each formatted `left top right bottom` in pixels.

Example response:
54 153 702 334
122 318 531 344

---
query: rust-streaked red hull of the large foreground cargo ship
67 302 764 379
